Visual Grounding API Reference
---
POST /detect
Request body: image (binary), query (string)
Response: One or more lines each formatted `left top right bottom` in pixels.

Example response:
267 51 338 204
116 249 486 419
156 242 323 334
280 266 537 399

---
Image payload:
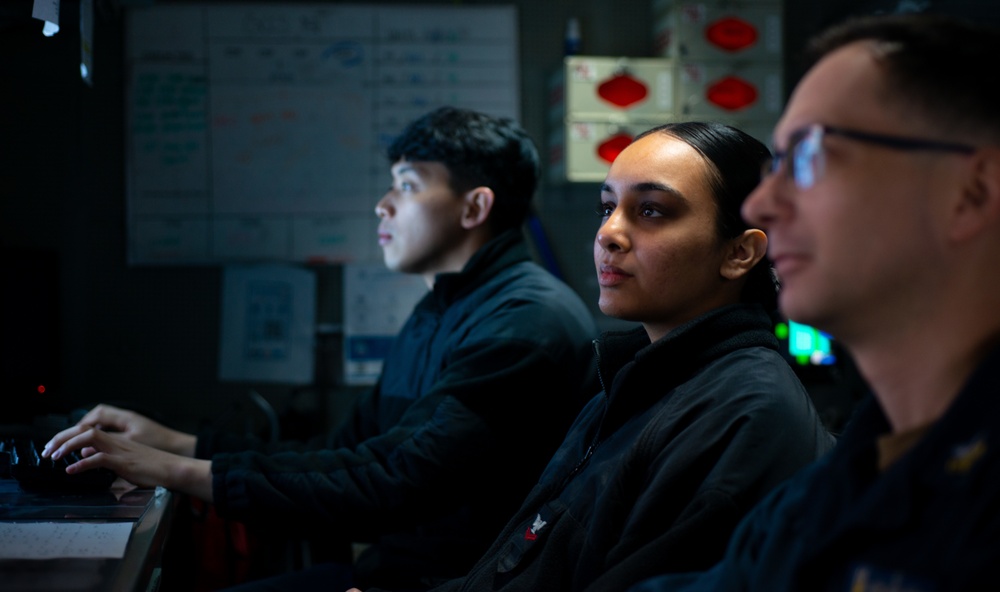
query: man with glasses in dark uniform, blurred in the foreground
633 10 1000 592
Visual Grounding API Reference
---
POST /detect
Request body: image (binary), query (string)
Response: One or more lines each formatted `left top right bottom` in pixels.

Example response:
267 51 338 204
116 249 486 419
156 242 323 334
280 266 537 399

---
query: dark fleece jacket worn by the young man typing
199 231 597 589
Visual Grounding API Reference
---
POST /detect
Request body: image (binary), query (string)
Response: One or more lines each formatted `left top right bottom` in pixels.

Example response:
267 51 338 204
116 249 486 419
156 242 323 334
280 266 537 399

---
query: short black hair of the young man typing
388 107 539 234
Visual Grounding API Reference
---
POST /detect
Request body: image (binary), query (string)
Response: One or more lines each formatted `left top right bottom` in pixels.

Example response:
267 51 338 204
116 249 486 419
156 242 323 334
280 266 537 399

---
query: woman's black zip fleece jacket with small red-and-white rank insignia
422 305 833 592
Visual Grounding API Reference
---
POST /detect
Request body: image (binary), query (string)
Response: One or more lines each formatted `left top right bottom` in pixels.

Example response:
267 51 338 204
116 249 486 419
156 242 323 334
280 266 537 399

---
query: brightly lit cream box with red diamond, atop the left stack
549 56 677 123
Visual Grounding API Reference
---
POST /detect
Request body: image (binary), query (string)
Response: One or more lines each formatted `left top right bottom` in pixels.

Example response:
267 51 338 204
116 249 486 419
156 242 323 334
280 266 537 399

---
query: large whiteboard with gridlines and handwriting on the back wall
125 3 520 265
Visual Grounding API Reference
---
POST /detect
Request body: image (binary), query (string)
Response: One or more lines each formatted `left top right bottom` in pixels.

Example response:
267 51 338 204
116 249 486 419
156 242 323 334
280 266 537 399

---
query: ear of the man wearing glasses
948 147 1000 242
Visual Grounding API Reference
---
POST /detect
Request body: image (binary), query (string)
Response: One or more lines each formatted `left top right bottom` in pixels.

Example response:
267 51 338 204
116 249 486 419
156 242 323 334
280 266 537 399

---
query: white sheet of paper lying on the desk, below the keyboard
0 522 132 559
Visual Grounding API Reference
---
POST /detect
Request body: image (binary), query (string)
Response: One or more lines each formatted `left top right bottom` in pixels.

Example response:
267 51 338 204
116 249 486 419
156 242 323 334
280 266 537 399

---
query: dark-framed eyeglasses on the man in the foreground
761 123 976 189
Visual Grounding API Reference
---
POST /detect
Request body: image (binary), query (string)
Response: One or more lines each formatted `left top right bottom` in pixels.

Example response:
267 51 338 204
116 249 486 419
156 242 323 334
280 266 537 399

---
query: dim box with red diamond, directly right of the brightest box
677 61 784 120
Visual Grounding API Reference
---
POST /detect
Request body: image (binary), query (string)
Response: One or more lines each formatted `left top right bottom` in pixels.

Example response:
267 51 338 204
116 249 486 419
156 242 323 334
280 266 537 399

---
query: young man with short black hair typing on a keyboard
47 108 597 590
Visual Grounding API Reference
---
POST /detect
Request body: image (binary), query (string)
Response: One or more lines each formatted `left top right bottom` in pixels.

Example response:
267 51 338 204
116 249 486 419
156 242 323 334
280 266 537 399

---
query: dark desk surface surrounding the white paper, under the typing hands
0 479 174 592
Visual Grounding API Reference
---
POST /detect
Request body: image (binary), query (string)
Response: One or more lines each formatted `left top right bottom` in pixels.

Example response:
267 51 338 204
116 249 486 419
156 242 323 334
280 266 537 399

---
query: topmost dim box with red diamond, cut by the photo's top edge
653 1 784 62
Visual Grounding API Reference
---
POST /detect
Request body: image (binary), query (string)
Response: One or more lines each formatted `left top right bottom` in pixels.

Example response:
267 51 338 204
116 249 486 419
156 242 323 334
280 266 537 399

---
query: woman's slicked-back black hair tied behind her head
636 121 778 312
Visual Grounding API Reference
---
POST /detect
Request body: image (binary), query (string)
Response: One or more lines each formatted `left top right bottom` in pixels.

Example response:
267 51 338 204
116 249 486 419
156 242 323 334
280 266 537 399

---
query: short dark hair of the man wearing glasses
805 13 1000 144
